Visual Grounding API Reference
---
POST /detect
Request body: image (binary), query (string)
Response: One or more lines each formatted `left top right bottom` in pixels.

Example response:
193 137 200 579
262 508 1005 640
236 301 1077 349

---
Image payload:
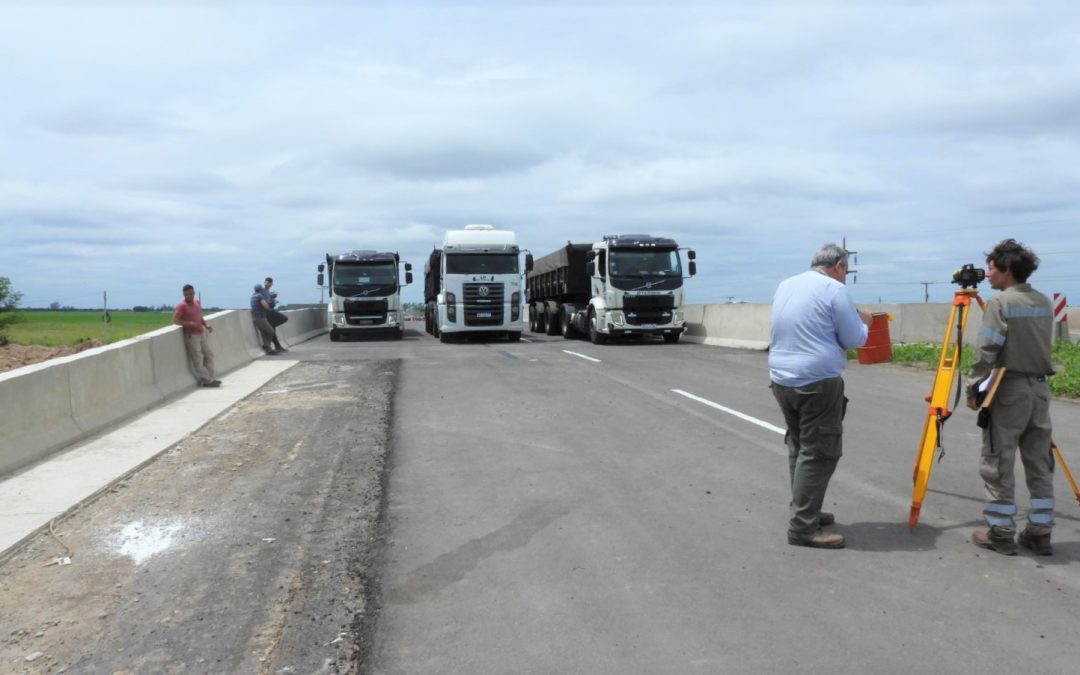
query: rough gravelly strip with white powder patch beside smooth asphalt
0 361 399 674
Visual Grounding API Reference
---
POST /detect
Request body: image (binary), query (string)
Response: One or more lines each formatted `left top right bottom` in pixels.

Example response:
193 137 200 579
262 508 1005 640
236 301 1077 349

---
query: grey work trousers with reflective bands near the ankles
978 374 1054 535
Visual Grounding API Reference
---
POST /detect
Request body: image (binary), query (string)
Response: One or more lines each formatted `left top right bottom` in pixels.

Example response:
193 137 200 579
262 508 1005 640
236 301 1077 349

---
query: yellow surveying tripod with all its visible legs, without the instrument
907 288 1080 529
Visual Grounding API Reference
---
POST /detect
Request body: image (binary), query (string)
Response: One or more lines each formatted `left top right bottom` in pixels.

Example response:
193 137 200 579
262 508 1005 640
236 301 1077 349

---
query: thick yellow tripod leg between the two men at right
907 289 982 528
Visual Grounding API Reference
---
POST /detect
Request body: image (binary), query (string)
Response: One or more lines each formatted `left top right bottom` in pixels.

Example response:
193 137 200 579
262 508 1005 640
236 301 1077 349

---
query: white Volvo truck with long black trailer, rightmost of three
526 234 698 345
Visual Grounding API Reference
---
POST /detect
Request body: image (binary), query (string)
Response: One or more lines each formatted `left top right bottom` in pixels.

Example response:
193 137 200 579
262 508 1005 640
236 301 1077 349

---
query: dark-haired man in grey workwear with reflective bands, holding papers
968 239 1054 555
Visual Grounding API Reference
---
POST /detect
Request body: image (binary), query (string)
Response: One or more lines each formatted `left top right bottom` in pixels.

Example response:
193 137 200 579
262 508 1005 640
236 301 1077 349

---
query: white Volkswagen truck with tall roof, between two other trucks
423 225 523 342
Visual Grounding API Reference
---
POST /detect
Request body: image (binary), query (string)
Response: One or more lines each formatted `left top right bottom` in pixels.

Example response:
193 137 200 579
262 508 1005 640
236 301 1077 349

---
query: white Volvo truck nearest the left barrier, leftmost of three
318 251 413 342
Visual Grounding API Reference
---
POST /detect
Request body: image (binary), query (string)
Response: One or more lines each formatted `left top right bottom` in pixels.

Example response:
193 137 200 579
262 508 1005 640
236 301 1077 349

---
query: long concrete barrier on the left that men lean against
0 308 326 475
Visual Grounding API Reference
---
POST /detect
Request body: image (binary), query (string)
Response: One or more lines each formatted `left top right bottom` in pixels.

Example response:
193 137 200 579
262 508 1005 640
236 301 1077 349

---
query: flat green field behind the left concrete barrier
5 310 173 347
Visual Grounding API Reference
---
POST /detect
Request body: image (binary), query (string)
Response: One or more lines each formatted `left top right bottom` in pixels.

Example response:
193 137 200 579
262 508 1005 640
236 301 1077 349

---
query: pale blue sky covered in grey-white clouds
0 0 1080 308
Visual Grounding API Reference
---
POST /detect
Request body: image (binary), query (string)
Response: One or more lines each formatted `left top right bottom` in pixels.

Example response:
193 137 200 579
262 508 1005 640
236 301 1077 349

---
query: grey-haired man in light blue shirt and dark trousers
769 244 870 549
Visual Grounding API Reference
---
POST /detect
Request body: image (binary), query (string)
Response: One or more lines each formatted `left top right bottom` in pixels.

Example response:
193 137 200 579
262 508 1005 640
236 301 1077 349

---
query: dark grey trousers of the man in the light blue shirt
772 377 848 536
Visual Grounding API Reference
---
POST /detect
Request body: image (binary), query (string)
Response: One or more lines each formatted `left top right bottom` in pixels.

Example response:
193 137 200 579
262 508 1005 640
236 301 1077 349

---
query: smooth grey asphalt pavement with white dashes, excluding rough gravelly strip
370 324 1080 674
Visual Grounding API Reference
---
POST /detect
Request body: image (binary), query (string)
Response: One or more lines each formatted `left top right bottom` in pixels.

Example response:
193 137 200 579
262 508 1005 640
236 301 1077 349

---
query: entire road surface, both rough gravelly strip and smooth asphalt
0 324 1080 675
